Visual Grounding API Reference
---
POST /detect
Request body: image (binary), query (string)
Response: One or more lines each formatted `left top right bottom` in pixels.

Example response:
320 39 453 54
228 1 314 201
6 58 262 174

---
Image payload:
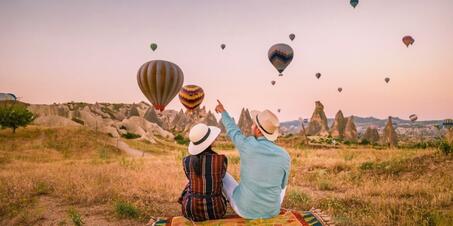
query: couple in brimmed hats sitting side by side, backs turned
179 101 291 221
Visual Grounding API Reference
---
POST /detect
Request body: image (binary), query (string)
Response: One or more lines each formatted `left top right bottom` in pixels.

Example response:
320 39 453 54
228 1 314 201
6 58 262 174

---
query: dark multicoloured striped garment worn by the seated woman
180 152 228 221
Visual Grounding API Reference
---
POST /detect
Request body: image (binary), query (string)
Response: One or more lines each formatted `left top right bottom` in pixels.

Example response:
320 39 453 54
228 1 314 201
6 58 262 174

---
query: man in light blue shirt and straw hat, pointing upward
215 100 291 219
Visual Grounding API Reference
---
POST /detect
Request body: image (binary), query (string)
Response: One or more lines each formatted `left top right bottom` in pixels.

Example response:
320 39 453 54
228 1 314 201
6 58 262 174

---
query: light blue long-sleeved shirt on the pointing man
222 111 291 219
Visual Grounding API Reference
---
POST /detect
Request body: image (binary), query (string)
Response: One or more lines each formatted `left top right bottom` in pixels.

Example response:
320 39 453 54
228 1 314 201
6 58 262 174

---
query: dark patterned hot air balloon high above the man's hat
267 43 294 76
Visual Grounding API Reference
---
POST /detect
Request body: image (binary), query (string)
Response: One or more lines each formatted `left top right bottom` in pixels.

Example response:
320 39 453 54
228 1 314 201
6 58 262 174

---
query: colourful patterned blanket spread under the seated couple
151 208 335 226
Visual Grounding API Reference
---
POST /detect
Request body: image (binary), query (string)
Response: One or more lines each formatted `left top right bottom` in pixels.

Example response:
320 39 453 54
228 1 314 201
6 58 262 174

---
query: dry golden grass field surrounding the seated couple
0 127 453 225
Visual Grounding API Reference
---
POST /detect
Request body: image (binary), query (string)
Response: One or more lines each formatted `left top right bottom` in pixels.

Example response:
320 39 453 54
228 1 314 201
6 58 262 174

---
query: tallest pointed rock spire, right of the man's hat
306 101 329 136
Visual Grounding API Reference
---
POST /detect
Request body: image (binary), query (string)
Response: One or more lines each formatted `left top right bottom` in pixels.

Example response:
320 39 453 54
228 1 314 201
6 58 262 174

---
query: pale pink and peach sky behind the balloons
0 0 453 121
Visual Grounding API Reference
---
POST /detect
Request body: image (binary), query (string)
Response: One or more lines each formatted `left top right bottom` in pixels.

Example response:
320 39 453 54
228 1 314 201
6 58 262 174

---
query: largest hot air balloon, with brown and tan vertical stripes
137 60 184 111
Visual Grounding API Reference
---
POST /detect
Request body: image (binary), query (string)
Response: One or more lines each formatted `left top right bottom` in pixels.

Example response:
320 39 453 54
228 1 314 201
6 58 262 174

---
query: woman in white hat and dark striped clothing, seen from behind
179 123 228 221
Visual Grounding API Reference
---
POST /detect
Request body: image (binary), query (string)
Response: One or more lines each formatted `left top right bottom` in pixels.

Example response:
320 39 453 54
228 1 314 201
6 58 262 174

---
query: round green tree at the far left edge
0 105 35 133
